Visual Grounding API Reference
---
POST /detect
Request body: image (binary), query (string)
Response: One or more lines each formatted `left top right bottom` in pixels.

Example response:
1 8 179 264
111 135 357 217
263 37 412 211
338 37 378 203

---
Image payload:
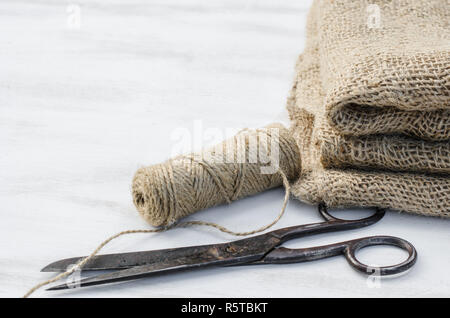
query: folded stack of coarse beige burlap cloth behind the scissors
287 0 450 217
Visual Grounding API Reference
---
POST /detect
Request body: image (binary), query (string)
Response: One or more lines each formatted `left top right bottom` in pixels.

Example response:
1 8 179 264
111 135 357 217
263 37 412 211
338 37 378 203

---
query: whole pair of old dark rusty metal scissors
42 204 417 290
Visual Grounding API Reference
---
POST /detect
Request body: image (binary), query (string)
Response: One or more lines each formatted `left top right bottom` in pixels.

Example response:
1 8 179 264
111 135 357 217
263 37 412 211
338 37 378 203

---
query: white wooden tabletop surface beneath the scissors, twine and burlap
0 0 450 297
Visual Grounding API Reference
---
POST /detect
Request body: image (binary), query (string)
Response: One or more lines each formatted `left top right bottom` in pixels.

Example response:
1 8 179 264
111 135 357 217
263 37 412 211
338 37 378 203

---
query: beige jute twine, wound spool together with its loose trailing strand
24 124 301 298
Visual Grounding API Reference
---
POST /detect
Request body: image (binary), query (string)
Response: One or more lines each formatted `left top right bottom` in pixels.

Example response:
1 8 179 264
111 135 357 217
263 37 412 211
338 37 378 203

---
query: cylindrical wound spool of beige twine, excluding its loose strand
132 124 301 227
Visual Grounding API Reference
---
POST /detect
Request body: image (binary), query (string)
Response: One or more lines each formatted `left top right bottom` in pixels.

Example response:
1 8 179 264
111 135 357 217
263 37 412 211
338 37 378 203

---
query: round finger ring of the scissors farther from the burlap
345 236 417 276
